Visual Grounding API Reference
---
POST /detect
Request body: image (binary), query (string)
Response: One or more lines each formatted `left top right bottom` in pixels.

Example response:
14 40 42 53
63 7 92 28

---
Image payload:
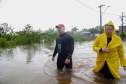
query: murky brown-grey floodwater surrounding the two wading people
0 42 126 84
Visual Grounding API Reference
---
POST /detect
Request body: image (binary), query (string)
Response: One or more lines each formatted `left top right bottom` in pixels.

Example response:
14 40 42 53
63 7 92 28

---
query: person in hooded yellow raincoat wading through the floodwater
93 21 126 79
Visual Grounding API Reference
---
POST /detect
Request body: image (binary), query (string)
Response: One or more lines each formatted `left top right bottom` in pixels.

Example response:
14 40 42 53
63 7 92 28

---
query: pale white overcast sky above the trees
0 0 126 30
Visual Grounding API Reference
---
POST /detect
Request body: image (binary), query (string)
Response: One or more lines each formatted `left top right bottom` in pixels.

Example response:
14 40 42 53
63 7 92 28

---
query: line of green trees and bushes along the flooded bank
0 23 99 48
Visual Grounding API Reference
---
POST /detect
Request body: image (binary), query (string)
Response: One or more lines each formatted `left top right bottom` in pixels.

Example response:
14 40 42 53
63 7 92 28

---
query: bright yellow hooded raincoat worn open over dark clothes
93 21 126 79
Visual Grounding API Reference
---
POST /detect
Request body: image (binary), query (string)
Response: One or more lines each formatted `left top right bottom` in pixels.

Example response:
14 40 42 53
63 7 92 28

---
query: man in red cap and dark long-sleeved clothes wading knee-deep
52 24 74 72
